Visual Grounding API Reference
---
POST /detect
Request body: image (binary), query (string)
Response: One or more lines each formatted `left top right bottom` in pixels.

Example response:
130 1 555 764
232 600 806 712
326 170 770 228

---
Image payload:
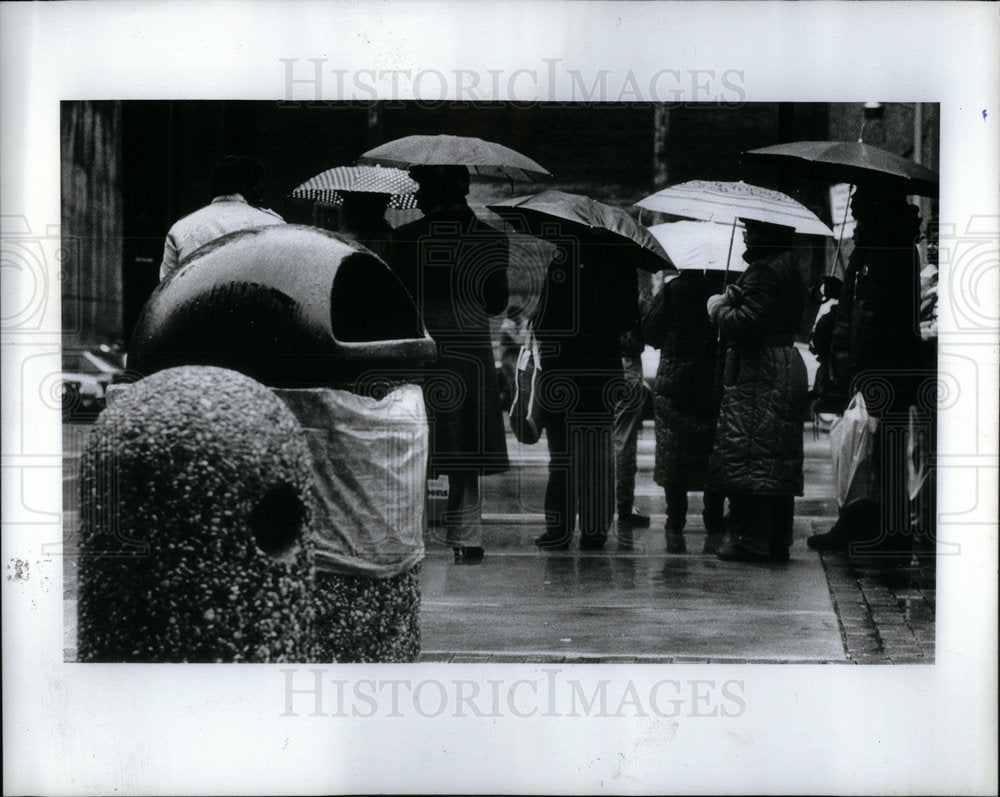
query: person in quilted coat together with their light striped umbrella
636 180 833 562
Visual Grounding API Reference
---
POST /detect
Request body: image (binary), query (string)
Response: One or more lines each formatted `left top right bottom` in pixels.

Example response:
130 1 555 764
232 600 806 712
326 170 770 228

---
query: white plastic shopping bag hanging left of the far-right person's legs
830 392 879 509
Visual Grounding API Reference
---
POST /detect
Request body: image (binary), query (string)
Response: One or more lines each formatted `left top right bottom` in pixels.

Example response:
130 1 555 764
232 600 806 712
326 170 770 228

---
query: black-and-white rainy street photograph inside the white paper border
61 101 939 664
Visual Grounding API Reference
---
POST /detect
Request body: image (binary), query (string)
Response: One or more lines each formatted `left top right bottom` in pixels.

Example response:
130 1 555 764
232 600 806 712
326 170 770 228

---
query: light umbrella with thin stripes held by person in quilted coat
636 180 833 238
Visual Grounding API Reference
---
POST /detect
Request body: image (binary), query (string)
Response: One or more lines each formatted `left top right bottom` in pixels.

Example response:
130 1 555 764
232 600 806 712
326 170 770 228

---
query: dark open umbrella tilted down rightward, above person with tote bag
486 190 674 273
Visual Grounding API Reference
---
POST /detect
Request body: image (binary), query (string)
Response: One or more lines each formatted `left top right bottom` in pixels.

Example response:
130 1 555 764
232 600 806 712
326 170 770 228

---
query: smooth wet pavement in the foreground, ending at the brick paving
421 519 846 662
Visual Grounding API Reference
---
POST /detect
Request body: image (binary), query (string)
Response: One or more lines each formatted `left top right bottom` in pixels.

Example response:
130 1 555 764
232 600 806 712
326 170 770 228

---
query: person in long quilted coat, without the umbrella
707 219 808 562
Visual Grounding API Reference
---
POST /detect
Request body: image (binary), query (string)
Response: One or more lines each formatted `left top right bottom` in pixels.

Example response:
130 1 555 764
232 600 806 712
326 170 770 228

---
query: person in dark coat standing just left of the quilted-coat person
644 270 726 553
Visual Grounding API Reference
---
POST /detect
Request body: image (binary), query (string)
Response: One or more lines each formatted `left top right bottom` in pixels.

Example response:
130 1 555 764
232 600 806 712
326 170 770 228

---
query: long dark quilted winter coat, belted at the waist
708 250 808 495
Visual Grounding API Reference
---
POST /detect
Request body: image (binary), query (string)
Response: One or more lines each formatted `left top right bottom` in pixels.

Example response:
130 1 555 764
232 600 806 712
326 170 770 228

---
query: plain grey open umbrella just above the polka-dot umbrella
358 134 552 182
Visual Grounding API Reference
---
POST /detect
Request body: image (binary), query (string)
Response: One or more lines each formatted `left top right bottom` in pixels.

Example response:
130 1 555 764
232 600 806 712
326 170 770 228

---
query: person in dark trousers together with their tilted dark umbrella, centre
488 190 674 551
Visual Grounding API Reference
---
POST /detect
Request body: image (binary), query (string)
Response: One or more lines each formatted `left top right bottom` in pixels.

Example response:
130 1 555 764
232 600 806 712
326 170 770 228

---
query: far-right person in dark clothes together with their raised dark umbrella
744 140 939 564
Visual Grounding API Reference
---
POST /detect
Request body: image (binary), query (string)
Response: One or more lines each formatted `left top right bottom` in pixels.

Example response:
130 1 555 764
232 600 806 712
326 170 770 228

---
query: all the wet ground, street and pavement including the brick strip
64 422 935 663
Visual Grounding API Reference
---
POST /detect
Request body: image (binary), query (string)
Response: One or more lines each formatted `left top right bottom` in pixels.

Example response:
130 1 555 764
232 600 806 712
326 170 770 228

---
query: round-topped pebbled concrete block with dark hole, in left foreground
78 367 319 662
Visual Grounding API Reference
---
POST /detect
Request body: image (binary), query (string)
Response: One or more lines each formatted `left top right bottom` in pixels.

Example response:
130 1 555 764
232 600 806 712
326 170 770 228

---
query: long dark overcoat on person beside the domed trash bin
389 205 509 476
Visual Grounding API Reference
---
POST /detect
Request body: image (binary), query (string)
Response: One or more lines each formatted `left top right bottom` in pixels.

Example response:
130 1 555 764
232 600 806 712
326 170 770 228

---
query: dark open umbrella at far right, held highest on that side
743 141 939 196
